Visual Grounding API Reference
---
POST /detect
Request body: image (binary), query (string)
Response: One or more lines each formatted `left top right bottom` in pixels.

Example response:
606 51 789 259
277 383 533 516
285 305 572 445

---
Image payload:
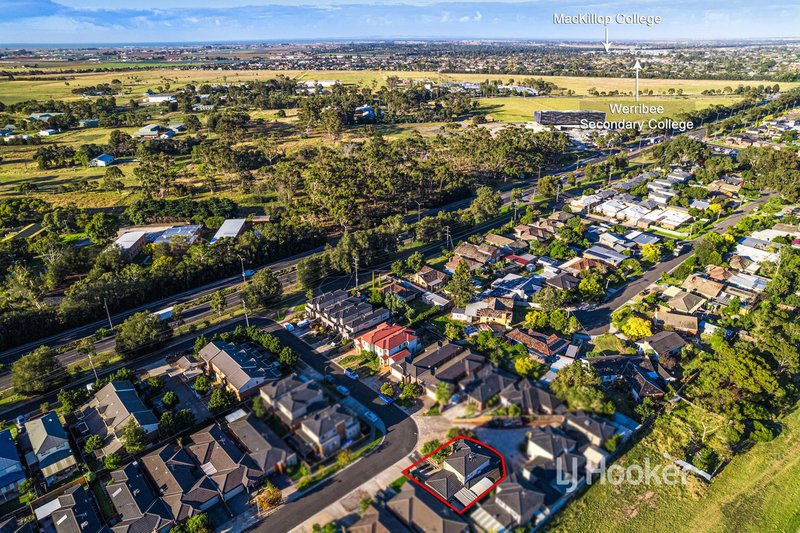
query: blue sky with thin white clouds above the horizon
0 0 800 44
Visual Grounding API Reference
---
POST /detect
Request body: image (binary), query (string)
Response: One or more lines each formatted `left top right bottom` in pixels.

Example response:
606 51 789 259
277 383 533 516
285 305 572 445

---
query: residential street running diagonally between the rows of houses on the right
574 195 769 335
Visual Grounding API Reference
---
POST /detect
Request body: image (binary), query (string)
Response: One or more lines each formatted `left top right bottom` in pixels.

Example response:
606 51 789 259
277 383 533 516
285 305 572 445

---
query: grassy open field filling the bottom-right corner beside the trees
550 410 800 533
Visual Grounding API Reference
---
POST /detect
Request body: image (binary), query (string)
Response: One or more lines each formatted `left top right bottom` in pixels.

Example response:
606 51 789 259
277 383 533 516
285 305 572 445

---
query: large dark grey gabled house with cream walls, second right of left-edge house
75 381 158 454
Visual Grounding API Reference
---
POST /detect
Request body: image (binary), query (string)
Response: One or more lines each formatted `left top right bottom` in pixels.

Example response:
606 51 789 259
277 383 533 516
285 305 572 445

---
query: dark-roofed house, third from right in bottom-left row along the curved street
141 444 220 522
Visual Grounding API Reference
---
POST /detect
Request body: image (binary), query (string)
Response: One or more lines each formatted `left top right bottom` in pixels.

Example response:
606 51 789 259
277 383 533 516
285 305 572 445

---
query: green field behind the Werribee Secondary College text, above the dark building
478 96 740 122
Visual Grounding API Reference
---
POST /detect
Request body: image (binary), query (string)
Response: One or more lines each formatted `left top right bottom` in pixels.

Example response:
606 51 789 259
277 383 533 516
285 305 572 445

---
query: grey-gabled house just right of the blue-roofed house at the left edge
25 411 77 485
